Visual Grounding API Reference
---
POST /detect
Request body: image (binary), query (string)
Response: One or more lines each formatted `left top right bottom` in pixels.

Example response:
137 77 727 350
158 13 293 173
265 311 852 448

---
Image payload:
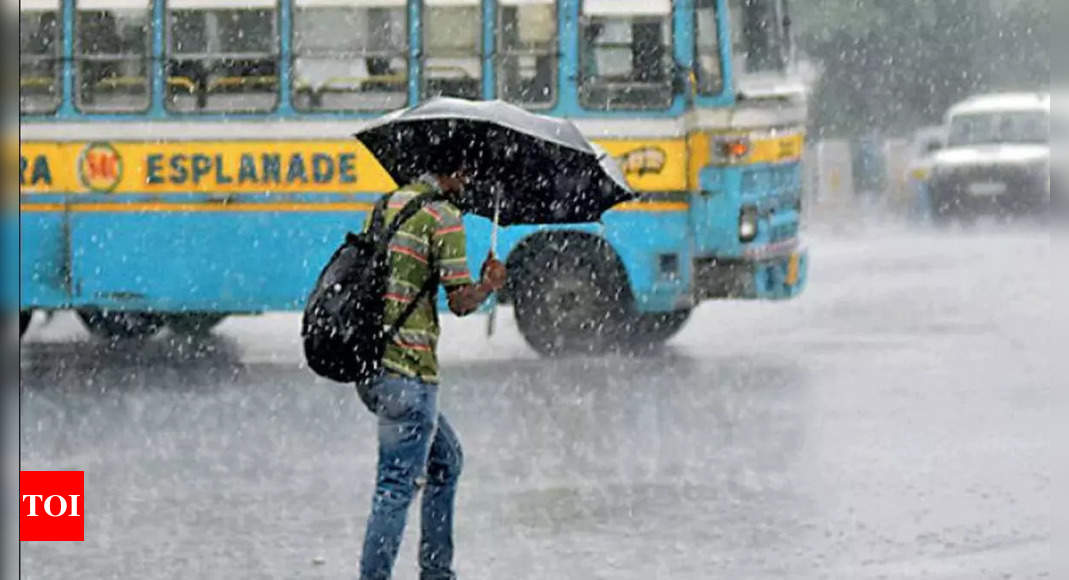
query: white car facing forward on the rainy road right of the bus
926 93 1051 220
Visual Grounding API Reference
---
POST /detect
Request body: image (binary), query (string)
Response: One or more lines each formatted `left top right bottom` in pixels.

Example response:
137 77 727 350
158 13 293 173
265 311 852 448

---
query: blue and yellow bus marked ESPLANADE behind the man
19 0 808 355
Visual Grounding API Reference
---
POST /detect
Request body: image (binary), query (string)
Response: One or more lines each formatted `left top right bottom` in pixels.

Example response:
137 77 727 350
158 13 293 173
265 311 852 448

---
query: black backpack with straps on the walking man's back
300 194 445 382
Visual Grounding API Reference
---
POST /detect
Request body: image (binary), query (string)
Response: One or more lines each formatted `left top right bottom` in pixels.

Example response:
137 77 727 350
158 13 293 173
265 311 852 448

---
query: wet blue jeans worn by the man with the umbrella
357 374 464 580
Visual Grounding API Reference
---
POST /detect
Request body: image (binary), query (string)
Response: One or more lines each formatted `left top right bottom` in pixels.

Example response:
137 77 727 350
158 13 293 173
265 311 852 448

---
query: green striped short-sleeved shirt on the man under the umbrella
367 176 472 382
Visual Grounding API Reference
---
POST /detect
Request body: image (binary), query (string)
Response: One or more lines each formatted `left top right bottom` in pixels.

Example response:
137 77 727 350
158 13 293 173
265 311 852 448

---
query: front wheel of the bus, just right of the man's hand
509 236 630 357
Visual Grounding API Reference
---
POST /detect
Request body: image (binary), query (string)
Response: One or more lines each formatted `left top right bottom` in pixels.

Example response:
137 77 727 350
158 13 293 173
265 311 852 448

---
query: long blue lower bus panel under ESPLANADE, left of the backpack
72 211 363 312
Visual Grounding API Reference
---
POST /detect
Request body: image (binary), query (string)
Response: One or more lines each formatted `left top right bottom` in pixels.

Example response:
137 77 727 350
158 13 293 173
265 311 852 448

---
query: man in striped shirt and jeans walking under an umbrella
357 150 506 580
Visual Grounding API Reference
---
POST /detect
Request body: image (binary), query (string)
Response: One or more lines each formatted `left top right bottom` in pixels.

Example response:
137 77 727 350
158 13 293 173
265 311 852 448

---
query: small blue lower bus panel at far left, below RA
20 210 71 309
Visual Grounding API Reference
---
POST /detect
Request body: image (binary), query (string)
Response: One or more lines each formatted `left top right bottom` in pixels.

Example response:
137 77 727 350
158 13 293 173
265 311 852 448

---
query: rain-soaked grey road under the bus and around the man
21 230 1056 580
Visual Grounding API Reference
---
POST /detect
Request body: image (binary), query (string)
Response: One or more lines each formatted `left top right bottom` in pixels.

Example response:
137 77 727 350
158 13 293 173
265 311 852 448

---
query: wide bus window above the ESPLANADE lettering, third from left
166 0 279 112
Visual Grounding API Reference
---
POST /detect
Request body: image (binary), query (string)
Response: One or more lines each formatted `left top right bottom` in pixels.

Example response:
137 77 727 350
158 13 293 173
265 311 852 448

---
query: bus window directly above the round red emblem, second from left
74 0 152 111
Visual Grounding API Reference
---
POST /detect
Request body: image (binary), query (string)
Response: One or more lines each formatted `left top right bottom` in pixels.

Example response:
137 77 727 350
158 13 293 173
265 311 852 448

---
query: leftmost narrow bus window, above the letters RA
18 0 61 113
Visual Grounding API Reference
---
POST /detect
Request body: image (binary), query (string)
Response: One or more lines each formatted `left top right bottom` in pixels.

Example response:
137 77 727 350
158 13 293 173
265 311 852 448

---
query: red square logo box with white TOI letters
18 471 86 542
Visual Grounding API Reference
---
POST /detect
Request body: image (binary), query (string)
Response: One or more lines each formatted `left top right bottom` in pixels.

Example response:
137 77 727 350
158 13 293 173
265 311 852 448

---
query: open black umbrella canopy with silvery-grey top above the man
356 97 635 225
